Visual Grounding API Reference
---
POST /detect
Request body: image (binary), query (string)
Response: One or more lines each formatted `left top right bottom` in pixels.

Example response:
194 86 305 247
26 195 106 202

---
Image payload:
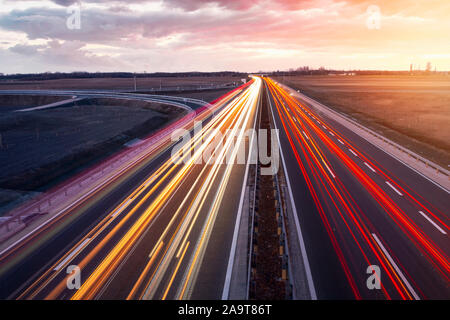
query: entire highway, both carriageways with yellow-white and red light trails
0 77 450 300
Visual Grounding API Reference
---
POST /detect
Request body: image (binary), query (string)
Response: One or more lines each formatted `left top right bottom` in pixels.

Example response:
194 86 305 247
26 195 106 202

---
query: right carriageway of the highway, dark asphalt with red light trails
265 78 450 299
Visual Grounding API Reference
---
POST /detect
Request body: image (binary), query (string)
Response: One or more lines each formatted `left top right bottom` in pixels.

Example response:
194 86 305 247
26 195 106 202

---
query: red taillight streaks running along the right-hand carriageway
266 79 449 298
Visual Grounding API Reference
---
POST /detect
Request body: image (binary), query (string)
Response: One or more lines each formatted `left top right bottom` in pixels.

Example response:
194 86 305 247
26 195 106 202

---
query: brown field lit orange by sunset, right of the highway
275 76 450 169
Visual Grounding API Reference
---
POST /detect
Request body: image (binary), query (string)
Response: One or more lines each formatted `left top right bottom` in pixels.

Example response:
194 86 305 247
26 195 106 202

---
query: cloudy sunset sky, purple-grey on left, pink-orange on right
0 0 450 74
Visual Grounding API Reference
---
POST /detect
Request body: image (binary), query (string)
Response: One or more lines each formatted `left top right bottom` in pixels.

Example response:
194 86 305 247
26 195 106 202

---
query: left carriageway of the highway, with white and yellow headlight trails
0 79 262 299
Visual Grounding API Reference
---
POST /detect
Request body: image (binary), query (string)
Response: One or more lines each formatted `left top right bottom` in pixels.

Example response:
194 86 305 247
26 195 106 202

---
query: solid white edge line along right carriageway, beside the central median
268 87 317 300
